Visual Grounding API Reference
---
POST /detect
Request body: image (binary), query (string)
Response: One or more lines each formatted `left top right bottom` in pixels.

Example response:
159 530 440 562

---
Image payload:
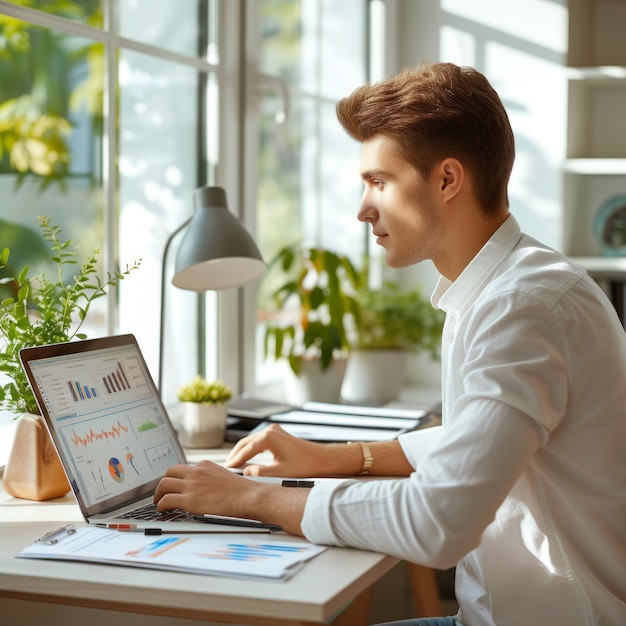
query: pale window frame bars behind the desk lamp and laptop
0 0 395 422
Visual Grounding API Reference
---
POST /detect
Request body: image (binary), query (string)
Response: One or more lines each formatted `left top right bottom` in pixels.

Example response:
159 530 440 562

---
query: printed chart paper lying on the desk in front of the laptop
17 526 326 581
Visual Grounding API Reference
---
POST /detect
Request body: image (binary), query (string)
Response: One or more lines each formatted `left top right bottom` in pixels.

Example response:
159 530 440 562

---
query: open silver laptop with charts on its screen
20 334 277 532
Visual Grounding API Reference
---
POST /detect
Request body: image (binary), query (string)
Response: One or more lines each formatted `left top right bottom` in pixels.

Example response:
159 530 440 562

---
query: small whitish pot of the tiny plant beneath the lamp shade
178 402 228 448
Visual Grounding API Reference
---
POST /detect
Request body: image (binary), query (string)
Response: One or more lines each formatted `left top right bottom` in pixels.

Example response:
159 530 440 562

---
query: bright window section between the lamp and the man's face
241 0 384 395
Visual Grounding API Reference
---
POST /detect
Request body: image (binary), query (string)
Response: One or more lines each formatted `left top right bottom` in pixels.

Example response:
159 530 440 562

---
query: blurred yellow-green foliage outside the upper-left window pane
0 0 104 190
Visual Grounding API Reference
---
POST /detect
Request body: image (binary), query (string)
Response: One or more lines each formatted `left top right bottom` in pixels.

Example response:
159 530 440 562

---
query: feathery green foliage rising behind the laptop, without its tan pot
0 215 141 417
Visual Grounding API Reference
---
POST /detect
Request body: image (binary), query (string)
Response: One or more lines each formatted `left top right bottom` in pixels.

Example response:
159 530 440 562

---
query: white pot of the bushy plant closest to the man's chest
341 350 407 403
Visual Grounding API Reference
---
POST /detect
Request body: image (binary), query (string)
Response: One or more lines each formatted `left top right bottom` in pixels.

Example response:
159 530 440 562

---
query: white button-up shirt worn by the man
302 216 626 626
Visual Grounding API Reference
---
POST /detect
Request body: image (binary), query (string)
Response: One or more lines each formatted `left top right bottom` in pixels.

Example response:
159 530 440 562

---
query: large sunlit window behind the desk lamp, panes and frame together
0 0 383 434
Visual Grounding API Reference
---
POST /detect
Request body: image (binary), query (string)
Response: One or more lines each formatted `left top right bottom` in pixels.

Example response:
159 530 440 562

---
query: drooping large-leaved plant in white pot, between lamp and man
264 244 360 404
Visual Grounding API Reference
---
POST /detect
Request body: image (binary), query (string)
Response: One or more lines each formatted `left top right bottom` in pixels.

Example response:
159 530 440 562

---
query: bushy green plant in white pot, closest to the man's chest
342 274 444 402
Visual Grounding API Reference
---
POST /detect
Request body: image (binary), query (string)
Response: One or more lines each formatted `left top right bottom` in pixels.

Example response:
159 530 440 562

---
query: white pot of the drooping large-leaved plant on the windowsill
284 359 347 406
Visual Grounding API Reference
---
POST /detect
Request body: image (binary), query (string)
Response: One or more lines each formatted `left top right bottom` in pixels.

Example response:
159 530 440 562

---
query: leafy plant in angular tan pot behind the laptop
0 216 141 500
